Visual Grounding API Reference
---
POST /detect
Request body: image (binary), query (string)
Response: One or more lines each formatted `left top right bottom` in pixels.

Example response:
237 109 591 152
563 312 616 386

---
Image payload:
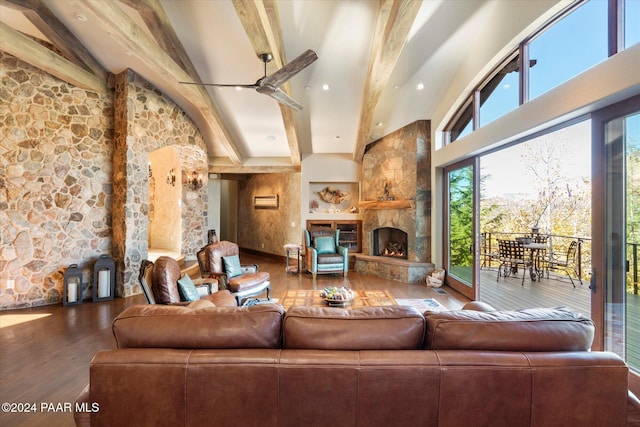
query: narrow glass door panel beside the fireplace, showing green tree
443 158 479 300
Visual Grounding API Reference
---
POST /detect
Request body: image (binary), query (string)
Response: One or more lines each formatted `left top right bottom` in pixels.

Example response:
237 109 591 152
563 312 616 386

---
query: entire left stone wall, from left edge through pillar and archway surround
0 52 208 309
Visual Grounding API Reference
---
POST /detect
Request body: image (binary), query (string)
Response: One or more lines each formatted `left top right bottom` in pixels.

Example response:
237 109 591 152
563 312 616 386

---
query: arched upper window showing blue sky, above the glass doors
443 0 640 145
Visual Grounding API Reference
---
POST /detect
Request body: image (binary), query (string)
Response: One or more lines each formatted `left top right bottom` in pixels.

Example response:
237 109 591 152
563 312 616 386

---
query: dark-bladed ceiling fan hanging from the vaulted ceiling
180 49 318 111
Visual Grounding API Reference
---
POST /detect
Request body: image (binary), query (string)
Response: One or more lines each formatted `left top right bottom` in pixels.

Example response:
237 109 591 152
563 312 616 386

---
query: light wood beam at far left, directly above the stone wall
0 22 107 93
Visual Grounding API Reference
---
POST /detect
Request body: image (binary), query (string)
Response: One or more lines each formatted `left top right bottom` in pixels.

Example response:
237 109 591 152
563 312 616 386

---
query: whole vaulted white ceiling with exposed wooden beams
0 0 555 173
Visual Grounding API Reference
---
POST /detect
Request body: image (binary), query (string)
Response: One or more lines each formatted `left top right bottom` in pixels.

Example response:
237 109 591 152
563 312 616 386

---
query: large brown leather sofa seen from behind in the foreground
75 304 628 427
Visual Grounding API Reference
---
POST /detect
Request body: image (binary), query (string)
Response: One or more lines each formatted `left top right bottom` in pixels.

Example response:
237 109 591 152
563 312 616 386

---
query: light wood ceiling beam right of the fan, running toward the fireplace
353 0 422 162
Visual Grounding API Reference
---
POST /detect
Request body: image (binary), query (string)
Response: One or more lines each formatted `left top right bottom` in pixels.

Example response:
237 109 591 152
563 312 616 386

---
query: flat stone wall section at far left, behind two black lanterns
0 51 113 309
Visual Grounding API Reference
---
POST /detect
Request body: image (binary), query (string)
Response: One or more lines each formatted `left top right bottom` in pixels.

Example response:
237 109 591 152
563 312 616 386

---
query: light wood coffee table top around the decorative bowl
278 289 397 310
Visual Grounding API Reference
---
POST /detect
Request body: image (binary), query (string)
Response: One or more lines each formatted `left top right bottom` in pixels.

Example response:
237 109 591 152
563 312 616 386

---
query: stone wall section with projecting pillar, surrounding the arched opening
113 70 208 296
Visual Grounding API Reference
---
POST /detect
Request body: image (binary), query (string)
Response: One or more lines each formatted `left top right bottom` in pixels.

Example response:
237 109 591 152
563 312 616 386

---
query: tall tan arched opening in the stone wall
148 147 182 261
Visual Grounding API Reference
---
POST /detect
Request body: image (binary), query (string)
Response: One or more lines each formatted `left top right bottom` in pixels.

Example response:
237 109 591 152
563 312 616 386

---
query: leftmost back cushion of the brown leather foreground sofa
113 304 284 349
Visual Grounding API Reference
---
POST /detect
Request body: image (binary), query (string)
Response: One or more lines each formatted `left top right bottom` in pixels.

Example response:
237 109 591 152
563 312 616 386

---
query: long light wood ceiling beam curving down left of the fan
65 0 242 165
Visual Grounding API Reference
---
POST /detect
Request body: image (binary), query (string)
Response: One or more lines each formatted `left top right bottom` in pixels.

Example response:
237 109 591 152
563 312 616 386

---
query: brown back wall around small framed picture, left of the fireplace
238 173 302 256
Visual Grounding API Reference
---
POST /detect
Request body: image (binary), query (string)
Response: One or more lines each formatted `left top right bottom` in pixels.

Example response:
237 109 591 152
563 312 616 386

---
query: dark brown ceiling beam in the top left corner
0 0 107 82
